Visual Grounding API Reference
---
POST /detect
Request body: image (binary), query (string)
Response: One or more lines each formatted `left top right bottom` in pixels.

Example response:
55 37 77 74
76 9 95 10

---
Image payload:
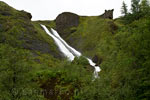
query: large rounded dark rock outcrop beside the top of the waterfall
55 12 79 37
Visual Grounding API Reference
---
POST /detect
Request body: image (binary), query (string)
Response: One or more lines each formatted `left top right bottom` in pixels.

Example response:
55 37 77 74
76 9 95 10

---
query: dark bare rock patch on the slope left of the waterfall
19 23 63 59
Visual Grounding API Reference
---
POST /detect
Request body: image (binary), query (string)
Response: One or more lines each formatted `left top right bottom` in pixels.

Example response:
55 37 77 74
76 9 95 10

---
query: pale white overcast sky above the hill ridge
0 0 131 20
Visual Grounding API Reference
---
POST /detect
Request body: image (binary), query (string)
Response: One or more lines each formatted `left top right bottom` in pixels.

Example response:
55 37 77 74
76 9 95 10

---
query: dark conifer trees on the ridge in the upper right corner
121 0 150 24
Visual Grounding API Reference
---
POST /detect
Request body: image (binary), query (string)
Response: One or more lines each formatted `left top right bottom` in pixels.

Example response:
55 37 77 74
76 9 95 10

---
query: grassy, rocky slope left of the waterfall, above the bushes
0 2 61 58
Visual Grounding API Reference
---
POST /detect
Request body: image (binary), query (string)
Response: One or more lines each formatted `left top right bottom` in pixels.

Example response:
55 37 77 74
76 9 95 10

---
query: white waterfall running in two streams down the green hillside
41 25 101 78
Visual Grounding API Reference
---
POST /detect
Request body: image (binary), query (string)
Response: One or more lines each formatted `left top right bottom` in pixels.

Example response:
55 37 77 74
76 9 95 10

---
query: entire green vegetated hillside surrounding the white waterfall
0 0 150 100
